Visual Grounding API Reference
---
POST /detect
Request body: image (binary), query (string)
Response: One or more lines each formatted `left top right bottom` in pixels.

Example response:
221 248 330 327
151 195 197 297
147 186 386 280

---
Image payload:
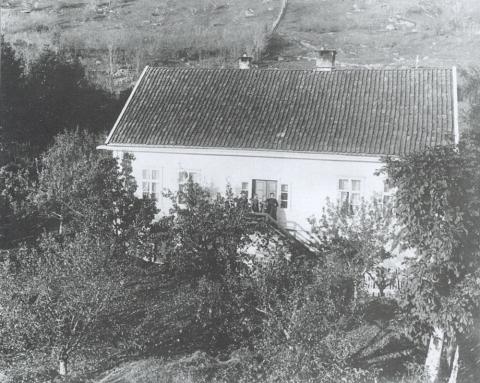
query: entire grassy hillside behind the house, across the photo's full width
1 0 480 90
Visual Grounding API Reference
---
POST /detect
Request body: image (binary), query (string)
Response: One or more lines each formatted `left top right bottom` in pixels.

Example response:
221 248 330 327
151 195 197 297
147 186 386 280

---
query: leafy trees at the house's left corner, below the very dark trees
0 130 156 248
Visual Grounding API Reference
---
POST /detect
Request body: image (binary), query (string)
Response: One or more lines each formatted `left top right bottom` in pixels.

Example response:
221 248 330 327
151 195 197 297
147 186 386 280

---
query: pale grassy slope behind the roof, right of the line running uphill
278 0 480 67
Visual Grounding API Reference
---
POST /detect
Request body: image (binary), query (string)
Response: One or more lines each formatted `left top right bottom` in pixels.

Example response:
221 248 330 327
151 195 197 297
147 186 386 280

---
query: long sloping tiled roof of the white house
107 67 454 155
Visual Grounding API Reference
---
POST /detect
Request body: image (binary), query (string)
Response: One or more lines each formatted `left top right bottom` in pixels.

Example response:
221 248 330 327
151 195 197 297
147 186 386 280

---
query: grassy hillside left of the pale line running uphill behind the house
1 0 282 89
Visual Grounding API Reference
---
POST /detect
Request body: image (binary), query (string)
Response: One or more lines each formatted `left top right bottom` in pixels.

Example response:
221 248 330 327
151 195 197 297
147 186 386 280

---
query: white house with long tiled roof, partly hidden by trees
100 57 458 238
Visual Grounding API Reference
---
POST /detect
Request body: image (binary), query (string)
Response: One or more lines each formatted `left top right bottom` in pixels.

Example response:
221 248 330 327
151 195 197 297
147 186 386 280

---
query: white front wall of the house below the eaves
114 150 383 229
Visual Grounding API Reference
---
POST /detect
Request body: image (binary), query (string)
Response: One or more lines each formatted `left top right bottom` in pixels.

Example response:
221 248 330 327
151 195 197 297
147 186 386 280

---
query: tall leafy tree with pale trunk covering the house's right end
383 133 480 382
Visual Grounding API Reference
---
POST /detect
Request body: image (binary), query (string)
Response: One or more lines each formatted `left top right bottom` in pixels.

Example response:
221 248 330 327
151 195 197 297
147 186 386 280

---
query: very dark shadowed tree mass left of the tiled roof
0 39 124 161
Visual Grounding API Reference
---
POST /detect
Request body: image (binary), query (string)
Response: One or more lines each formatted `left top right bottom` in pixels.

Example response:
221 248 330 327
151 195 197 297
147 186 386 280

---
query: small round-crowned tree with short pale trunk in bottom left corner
0 232 139 375
